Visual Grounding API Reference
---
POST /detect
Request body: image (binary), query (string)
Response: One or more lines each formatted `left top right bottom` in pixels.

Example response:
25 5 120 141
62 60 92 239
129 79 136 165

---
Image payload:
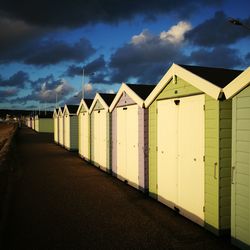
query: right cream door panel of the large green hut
178 95 205 223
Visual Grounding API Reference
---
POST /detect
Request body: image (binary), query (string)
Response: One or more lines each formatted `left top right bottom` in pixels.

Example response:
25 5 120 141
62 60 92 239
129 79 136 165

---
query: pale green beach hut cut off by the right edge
223 67 250 249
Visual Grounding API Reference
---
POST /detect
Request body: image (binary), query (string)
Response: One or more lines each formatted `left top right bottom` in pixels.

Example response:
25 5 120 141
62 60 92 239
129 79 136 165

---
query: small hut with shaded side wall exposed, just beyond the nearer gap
63 104 78 151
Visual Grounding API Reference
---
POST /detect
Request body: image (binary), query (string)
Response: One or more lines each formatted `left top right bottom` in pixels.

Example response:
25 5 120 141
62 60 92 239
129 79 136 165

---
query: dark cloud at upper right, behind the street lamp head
186 11 250 47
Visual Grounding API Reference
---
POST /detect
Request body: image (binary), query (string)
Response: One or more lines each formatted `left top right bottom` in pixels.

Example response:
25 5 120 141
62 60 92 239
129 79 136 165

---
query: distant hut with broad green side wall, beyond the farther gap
35 111 54 133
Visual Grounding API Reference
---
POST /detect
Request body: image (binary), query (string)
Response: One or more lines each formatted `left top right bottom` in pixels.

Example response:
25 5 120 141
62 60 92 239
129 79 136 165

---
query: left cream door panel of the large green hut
157 100 178 207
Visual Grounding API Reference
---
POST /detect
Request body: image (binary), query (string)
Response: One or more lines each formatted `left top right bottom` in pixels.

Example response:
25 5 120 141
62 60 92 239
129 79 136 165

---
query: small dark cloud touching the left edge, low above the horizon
0 71 30 88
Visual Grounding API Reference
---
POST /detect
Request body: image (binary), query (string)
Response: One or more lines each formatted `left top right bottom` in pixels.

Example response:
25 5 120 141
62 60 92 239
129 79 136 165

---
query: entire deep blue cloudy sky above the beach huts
0 0 250 110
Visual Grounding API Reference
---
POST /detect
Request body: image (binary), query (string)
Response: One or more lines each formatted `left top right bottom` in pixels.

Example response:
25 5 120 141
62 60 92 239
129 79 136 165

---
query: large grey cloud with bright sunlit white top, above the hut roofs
109 22 190 83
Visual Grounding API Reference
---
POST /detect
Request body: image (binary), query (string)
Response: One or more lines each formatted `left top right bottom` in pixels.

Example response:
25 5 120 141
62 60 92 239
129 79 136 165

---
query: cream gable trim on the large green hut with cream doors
145 63 222 108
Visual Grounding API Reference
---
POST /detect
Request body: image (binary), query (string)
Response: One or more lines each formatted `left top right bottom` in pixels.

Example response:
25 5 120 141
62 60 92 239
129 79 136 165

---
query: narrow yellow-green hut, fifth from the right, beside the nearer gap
77 99 93 161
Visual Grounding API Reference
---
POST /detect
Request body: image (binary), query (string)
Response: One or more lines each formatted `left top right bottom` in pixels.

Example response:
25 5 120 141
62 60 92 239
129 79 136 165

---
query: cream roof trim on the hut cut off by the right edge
223 67 250 99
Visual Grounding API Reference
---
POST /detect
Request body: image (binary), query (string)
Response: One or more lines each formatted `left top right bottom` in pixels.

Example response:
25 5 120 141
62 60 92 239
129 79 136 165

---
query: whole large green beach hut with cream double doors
145 64 241 234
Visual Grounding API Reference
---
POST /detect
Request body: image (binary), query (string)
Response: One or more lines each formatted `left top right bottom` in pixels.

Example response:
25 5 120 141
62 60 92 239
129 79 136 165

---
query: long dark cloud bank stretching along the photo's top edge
0 0 224 27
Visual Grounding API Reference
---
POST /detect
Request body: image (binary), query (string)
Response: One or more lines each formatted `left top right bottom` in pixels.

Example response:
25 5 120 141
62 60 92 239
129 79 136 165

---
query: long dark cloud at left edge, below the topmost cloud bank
0 38 96 66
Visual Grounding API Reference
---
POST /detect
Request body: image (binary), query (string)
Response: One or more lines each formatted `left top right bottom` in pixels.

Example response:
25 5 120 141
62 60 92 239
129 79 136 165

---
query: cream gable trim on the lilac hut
109 83 144 112
